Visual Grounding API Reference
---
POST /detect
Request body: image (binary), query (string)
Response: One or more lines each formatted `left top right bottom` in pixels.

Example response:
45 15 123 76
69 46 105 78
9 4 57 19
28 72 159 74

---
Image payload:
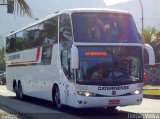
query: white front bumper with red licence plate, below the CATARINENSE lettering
71 93 143 108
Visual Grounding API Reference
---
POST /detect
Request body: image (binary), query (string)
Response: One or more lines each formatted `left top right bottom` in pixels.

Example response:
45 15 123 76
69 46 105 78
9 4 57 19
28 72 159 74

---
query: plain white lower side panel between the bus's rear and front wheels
6 45 60 101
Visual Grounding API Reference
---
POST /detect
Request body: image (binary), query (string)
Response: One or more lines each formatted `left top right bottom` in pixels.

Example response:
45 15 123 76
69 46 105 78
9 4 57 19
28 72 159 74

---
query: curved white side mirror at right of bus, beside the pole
143 44 155 65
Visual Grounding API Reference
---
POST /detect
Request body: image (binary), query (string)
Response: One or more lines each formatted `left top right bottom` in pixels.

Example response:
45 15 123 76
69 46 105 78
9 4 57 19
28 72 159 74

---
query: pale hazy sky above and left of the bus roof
0 0 129 48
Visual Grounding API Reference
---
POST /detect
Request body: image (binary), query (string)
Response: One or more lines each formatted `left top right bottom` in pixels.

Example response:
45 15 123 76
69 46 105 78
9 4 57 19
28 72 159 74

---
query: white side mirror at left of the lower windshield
71 44 79 69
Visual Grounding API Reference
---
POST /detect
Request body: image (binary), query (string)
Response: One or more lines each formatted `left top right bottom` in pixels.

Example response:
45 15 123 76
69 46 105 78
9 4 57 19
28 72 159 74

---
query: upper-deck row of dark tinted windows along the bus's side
6 17 58 53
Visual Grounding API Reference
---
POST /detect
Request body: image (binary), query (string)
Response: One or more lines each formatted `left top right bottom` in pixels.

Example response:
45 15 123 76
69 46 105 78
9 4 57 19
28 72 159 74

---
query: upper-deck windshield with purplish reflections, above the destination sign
72 13 140 43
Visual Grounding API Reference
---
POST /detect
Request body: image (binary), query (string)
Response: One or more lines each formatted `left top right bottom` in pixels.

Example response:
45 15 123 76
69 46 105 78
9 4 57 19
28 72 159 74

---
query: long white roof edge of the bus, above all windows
6 8 130 37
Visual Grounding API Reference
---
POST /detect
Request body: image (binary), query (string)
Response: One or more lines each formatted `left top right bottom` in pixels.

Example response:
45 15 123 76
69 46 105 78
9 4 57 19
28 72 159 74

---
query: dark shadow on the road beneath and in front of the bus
11 97 143 119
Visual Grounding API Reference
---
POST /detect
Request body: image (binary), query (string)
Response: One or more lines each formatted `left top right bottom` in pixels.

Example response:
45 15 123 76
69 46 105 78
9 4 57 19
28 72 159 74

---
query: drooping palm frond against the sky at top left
0 0 32 18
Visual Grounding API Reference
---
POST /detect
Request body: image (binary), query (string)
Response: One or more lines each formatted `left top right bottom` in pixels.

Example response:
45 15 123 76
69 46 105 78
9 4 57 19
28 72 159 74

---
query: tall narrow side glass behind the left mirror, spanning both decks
59 14 73 79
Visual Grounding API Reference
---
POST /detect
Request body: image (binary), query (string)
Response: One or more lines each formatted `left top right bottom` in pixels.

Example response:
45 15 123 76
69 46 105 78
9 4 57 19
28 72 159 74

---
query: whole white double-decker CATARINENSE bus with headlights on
6 9 154 109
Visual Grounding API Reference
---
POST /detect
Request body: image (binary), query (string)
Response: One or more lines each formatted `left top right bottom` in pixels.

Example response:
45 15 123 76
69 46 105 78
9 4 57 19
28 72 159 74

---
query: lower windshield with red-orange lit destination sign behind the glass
77 46 142 85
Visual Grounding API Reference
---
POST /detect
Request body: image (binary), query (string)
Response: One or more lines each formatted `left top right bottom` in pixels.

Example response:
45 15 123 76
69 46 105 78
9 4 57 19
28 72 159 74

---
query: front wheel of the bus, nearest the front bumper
54 86 63 110
